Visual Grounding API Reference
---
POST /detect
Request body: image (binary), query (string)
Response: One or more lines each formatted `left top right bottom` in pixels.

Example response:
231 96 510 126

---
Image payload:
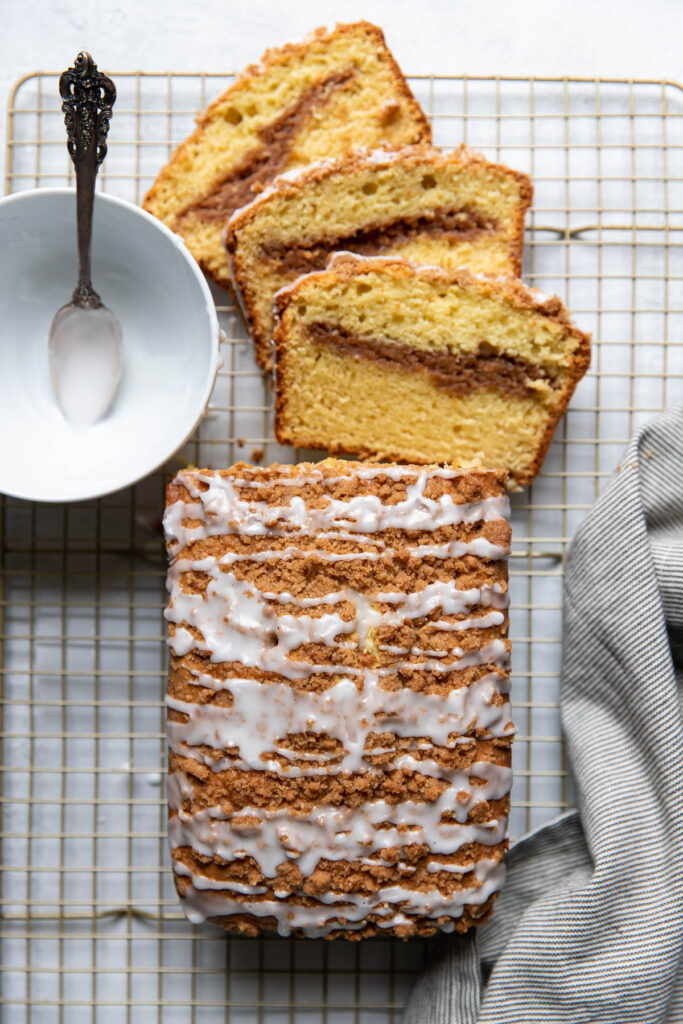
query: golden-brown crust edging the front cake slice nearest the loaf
273 253 591 486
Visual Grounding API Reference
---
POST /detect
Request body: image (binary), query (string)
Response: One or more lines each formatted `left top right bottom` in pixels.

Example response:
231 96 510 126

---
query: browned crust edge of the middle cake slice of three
225 144 533 370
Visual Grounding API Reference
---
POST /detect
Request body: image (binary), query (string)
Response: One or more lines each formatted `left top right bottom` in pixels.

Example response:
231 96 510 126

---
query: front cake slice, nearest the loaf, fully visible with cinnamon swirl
274 253 590 484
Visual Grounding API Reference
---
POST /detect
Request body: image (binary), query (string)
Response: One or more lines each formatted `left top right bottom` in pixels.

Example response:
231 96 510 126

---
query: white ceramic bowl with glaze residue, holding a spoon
0 188 219 502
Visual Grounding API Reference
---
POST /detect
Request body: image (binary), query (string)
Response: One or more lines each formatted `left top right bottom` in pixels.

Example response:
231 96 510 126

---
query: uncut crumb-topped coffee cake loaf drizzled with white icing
164 460 513 938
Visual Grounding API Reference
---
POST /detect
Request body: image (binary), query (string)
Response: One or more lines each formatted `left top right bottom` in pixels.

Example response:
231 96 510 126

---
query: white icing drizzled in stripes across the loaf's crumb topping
164 466 514 935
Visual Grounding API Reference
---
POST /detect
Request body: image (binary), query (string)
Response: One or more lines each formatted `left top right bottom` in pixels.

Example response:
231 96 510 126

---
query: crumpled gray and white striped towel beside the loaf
403 407 683 1024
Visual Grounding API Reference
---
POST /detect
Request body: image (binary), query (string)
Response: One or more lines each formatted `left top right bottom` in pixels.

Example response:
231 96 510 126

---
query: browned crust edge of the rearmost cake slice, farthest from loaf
142 20 431 290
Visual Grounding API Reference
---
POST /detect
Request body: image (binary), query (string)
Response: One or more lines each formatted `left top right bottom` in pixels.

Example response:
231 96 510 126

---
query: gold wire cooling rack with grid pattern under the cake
0 72 683 1024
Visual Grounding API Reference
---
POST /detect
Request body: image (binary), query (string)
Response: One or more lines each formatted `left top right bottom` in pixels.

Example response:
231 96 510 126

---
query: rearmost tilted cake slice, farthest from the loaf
143 22 431 287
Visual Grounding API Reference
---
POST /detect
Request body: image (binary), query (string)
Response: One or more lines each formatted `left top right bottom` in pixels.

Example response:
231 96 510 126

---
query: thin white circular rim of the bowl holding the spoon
0 186 222 505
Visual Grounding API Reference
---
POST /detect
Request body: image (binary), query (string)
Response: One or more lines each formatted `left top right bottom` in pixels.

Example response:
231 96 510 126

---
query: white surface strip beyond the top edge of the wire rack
0 0 683 179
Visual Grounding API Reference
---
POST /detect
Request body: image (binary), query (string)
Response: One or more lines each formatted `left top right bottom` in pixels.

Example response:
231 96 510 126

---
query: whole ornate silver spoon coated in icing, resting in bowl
48 53 122 425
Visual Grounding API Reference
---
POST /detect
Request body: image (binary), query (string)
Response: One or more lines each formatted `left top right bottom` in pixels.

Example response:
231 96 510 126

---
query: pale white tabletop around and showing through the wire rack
0 0 683 1024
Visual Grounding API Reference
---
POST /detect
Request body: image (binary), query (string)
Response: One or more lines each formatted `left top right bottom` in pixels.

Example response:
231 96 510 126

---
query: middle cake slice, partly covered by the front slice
225 145 531 369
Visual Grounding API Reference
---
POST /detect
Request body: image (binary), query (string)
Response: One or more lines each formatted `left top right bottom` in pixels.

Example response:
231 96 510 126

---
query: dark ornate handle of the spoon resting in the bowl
59 52 116 309
